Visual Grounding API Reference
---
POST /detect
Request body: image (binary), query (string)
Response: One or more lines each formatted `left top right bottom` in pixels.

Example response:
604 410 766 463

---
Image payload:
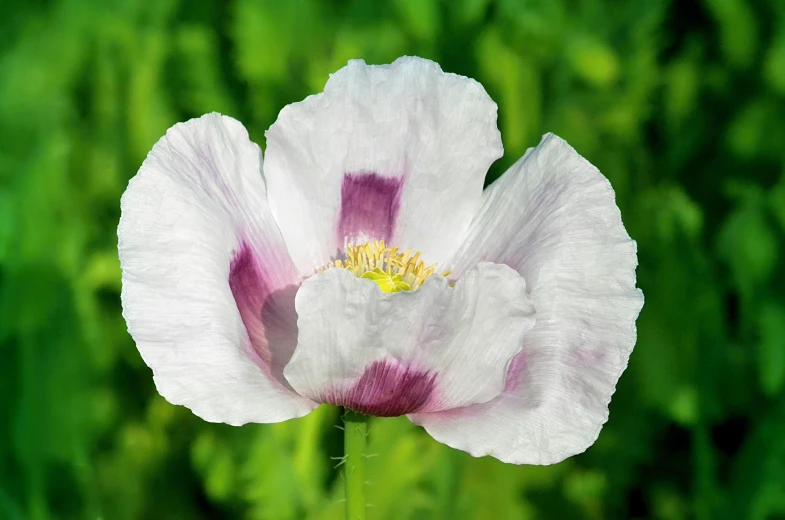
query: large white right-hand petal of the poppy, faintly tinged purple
411 135 643 464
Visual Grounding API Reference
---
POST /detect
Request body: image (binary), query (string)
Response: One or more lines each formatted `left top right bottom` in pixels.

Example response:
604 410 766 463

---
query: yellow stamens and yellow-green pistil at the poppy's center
326 240 451 293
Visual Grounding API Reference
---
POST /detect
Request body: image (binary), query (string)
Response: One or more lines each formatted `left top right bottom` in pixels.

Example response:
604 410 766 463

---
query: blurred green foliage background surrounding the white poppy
0 0 785 520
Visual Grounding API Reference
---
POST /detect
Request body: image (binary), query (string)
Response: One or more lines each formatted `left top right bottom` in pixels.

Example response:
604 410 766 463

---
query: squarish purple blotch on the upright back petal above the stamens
338 172 403 244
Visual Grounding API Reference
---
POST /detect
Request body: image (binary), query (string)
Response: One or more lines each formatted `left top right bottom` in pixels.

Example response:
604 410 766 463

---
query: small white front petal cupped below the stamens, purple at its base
284 263 534 416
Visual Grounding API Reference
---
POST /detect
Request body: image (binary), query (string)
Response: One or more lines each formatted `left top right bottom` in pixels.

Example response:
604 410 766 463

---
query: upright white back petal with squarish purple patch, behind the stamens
264 57 502 275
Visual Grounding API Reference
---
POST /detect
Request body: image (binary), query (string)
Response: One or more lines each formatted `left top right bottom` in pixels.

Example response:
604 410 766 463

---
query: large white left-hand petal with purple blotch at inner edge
118 114 315 424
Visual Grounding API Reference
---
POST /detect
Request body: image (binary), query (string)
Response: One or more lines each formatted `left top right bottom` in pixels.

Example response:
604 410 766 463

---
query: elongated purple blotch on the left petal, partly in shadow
229 241 297 389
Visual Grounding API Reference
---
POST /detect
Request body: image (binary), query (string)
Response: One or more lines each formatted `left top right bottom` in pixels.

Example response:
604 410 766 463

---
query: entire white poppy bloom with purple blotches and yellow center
118 57 643 464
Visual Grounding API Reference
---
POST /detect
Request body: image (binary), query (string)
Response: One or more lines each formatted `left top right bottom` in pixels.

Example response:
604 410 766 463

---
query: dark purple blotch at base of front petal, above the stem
322 361 436 417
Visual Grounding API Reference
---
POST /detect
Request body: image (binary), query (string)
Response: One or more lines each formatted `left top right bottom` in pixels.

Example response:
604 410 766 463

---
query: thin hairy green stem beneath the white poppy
343 410 368 520
